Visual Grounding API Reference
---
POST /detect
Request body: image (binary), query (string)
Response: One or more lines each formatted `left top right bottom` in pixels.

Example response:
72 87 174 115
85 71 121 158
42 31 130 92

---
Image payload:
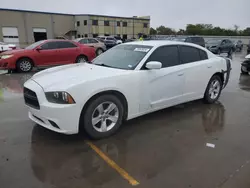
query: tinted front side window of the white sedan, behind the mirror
147 46 180 68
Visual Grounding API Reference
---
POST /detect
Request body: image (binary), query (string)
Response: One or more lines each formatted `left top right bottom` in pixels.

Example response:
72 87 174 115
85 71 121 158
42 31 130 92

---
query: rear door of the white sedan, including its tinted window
179 45 213 102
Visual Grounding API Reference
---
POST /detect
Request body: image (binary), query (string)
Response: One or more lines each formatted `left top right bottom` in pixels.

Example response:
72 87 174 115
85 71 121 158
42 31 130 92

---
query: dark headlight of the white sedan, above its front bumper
45 91 75 104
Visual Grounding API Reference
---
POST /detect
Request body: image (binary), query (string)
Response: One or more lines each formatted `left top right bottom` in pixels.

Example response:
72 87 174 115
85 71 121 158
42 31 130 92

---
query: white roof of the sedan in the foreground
122 40 205 48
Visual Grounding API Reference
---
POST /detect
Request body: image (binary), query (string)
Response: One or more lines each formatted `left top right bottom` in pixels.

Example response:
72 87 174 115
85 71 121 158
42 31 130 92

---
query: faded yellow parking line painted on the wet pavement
87 142 139 186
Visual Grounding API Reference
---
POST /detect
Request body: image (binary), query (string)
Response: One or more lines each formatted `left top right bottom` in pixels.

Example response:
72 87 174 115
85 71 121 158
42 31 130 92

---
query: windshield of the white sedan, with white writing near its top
93 44 152 70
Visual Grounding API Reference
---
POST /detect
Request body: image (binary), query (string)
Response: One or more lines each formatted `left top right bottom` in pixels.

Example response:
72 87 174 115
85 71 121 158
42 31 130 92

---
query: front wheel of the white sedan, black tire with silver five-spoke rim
81 95 124 139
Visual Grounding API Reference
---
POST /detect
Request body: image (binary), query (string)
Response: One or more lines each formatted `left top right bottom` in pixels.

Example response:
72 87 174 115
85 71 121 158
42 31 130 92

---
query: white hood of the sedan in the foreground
31 63 128 90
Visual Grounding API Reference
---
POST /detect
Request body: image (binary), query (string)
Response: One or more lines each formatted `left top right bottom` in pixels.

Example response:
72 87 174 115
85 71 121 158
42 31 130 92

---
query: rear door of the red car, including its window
58 41 80 65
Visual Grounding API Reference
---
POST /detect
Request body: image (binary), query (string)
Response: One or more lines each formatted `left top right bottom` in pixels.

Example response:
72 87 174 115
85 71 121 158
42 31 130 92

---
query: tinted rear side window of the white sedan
180 46 200 64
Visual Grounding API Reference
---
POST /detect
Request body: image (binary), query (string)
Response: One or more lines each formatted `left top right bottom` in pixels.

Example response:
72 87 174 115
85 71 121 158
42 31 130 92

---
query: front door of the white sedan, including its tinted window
140 46 184 111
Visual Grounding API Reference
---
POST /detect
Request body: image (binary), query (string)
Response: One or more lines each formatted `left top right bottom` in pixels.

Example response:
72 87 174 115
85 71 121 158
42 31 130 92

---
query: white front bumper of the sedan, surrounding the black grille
24 80 81 134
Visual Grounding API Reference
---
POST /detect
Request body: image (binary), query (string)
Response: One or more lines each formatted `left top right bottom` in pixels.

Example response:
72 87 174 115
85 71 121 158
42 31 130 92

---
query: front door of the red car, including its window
34 41 60 67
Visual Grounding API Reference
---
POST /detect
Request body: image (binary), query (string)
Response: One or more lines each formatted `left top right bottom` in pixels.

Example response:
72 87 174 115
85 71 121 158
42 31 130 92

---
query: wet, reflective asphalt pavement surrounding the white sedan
0 52 250 188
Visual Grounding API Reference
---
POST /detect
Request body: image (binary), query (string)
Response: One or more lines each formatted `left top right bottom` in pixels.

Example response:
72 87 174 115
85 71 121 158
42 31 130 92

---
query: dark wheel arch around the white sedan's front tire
79 90 128 130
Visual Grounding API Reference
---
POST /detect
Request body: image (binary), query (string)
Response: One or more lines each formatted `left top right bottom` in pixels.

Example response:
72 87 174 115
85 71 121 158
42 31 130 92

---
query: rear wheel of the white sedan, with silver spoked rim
203 75 222 104
